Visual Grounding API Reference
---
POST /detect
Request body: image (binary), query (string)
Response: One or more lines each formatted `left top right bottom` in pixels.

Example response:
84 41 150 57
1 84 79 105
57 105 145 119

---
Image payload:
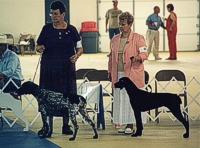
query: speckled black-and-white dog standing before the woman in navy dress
16 81 98 140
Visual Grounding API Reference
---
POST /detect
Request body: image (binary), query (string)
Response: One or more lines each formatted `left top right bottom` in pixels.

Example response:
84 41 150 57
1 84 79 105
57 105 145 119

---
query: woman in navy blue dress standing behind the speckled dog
36 1 83 134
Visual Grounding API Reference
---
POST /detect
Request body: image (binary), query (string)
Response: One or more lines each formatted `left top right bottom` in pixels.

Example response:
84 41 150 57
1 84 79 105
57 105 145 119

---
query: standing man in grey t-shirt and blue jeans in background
105 0 122 48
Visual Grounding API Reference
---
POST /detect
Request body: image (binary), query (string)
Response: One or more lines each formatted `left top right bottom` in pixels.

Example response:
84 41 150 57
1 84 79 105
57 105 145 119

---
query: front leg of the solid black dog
131 109 143 137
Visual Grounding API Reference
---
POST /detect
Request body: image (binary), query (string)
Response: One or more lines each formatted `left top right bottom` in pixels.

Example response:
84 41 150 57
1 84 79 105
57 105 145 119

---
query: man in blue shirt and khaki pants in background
146 6 166 60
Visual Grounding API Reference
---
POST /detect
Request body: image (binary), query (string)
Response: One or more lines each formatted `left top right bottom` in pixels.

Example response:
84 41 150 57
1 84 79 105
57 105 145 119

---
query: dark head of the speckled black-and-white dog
15 81 39 95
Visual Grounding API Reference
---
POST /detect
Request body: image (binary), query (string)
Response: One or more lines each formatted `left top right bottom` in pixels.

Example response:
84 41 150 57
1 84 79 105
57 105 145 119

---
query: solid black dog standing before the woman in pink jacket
115 77 189 138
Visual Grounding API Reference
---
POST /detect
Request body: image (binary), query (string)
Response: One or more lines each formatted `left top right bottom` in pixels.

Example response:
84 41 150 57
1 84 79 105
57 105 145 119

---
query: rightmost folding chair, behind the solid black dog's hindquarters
155 70 188 122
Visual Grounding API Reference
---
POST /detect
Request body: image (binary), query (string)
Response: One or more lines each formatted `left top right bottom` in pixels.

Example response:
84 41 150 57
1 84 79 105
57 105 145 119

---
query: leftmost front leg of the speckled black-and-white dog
38 106 49 138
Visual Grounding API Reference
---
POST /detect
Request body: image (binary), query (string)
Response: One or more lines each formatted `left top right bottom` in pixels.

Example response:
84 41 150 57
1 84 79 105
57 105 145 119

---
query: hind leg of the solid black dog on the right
168 104 189 138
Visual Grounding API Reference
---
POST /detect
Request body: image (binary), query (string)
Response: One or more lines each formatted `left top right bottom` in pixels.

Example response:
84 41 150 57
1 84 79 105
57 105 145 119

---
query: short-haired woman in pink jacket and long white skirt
108 12 148 134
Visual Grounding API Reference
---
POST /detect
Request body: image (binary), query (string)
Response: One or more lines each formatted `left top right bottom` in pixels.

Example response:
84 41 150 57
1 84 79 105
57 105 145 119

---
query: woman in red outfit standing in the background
165 4 177 60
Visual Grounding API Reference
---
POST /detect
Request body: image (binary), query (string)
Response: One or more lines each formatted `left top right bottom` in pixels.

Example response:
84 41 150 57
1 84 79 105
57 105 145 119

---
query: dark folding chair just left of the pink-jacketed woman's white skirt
85 70 113 121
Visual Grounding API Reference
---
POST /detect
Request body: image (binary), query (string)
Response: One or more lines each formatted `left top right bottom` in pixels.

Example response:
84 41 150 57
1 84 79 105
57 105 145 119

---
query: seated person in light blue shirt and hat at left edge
0 34 24 93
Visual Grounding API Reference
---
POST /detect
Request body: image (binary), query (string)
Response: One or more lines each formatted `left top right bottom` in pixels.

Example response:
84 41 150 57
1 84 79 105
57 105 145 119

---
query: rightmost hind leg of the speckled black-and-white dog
79 106 98 139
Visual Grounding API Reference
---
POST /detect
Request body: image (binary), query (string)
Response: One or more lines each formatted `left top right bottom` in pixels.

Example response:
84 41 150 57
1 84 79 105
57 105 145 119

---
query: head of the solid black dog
114 77 137 89
